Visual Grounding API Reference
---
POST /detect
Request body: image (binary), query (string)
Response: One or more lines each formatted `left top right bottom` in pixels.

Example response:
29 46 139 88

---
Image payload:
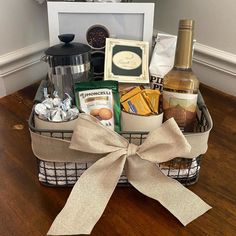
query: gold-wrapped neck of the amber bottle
174 23 193 69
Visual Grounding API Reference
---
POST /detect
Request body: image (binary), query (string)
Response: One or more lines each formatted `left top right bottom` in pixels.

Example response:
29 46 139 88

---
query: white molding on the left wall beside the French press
0 40 49 97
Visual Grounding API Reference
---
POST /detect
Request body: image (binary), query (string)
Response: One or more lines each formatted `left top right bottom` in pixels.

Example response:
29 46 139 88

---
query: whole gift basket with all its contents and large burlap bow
29 3 213 232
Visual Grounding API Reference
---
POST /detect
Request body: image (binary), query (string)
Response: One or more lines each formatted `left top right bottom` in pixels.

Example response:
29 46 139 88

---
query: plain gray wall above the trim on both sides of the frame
0 0 236 55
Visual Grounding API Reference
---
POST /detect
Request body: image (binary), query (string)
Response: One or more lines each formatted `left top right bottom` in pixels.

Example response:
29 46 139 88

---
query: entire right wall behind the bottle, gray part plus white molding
135 0 236 96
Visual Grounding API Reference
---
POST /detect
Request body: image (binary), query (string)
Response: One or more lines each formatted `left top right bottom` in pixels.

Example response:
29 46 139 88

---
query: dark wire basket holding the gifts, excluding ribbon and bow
29 87 212 187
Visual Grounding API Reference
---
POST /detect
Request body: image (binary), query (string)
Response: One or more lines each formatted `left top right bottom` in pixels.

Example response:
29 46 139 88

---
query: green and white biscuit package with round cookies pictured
75 80 120 131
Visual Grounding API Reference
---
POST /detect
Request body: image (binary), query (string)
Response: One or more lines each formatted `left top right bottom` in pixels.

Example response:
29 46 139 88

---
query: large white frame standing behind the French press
47 1 154 52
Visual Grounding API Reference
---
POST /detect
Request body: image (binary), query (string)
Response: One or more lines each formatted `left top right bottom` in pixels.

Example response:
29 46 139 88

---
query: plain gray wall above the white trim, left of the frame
0 0 48 55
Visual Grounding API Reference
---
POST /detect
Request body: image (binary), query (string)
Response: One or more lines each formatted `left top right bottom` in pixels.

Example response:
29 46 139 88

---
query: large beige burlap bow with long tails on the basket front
48 114 211 235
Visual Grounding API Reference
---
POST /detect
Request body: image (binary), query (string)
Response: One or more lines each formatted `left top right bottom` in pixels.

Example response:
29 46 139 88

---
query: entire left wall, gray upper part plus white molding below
0 0 48 97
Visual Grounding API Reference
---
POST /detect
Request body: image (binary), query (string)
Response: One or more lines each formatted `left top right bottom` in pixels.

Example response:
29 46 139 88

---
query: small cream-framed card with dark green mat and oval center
104 38 149 83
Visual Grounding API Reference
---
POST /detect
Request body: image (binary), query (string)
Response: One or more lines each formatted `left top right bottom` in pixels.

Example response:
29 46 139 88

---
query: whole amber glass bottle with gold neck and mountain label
163 20 199 132
